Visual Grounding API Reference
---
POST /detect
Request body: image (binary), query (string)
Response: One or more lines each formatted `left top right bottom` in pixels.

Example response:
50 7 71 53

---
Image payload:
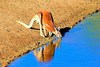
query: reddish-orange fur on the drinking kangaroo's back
40 11 55 32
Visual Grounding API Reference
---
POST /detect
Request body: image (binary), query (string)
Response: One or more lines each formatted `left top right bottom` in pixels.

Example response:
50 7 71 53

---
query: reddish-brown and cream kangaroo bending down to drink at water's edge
16 10 62 38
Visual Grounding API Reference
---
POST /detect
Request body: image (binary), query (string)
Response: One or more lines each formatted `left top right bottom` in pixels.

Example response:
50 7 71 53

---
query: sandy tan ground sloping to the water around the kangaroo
0 0 100 67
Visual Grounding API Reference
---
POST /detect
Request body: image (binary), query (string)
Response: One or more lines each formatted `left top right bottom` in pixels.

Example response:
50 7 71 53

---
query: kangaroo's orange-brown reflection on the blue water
34 39 61 62
